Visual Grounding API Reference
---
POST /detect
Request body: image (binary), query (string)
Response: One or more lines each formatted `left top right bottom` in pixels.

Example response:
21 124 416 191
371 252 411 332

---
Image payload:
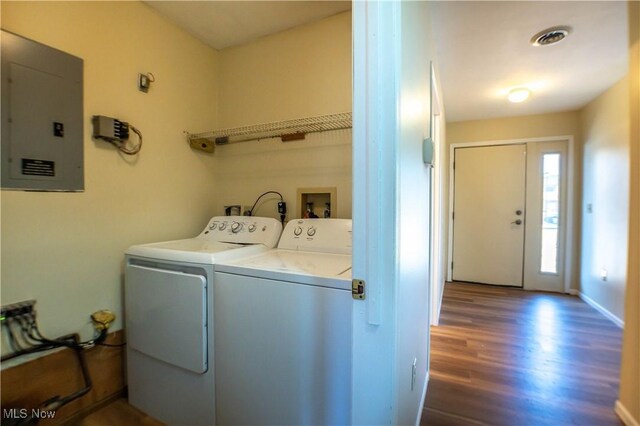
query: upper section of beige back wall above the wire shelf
219 11 351 127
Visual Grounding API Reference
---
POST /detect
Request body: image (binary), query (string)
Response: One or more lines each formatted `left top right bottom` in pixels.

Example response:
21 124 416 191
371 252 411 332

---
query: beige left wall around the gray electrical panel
1 2 219 347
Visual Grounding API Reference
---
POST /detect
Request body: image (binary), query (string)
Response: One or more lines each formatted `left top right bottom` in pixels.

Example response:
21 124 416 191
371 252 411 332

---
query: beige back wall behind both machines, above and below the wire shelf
212 12 352 219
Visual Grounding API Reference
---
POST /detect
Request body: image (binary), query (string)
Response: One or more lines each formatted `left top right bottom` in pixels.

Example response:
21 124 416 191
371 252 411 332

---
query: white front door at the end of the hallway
452 144 526 287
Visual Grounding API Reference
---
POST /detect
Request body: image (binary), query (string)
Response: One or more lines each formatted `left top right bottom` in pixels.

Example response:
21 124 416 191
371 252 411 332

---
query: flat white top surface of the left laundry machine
126 238 267 264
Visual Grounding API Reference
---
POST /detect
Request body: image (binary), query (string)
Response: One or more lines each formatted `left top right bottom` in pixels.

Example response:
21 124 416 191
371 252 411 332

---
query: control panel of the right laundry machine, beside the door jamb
278 219 352 254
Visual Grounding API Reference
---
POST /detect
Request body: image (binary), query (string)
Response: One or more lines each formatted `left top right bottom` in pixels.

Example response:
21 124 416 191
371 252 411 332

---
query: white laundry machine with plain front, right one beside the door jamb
214 219 353 425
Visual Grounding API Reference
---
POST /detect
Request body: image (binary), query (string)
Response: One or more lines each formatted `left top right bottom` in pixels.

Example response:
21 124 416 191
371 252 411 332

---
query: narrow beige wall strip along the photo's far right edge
616 1 640 425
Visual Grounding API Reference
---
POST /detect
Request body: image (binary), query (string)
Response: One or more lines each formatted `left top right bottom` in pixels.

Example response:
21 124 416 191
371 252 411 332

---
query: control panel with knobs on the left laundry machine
197 216 282 247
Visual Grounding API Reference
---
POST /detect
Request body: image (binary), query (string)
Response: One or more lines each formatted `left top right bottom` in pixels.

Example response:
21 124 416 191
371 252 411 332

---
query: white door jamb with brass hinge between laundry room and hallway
351 1 402 424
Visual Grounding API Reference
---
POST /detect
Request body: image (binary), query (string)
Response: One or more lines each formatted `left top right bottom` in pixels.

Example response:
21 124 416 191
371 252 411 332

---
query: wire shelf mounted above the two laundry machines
189 112 353 152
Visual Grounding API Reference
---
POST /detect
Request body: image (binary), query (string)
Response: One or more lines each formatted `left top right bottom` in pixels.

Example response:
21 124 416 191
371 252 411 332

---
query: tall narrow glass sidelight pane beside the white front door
540 153 560 274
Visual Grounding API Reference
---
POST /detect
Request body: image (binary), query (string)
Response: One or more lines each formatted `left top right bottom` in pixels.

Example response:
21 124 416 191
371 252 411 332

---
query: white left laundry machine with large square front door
125 216 282 425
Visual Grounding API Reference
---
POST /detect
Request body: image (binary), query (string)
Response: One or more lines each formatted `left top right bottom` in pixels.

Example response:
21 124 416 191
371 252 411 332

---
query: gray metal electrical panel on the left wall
1 31 84 191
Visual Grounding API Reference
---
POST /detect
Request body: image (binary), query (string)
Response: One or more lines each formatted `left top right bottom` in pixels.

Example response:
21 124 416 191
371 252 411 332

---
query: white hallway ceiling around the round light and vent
433 1 629 121
